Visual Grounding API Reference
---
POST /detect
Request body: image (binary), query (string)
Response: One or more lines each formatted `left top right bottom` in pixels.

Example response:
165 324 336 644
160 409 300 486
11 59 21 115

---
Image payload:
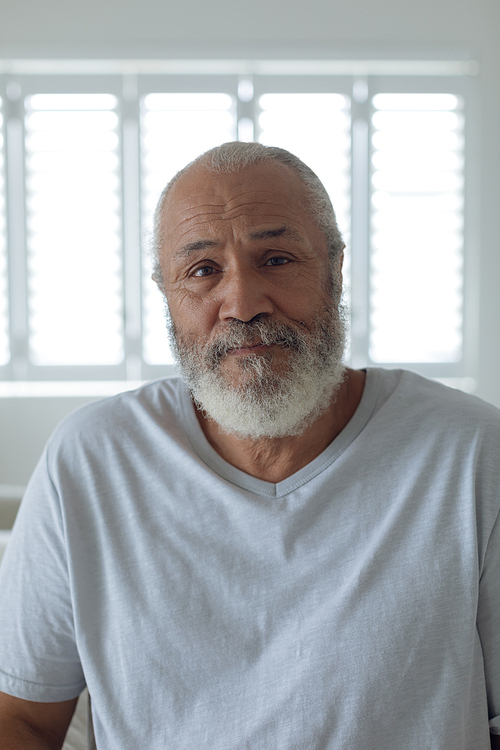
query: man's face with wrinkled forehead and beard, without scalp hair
160 163 343 435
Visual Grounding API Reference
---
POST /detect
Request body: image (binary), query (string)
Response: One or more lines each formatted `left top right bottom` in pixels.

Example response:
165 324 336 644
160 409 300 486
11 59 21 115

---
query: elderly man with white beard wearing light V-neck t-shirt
0 143 500 750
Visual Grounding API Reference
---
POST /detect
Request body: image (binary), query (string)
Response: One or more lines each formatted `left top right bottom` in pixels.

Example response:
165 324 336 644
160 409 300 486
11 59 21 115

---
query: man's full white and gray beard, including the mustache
167 308 345 439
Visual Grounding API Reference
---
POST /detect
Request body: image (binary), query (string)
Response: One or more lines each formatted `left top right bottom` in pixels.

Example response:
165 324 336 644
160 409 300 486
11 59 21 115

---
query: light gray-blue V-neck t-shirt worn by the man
0 370 500 750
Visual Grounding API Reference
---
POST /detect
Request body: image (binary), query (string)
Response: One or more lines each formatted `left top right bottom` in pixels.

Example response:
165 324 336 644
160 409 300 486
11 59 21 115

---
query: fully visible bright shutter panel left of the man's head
25 94 123 365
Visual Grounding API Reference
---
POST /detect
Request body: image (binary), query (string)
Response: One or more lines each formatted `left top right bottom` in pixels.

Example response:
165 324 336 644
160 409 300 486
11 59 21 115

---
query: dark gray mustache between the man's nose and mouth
204 320 305 366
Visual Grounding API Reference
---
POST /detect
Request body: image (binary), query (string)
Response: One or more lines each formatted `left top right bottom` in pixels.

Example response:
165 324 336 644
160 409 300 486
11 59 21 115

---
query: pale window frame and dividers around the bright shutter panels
0 61 479 382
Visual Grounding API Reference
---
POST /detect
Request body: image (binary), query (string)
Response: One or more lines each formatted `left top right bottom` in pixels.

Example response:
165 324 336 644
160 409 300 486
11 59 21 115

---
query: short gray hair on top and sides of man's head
151 141 345 294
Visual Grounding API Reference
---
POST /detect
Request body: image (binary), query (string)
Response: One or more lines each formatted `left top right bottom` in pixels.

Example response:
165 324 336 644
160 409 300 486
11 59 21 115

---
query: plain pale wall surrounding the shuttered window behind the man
0 0 500 494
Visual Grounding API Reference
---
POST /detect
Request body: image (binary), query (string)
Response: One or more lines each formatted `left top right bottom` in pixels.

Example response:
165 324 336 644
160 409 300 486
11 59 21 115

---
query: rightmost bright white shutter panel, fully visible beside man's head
369 94 464 363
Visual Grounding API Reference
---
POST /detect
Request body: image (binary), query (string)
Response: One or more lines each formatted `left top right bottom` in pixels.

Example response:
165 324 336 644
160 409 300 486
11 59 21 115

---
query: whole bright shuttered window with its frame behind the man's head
0 61 474 381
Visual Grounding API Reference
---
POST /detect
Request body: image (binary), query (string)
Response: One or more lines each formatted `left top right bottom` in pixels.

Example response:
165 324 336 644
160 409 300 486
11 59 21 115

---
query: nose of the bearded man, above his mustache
218 269 274 323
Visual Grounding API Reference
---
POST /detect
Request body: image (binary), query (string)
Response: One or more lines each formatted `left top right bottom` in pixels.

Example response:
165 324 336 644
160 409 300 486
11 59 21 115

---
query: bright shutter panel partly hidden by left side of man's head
141 93 236 364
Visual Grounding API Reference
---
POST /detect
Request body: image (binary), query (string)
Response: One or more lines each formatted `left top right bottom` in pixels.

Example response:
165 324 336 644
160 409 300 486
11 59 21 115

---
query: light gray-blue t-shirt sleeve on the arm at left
0 450 85 702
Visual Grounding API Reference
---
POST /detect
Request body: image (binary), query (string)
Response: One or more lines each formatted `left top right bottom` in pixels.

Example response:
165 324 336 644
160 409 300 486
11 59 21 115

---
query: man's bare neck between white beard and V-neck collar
197 369 365 483
